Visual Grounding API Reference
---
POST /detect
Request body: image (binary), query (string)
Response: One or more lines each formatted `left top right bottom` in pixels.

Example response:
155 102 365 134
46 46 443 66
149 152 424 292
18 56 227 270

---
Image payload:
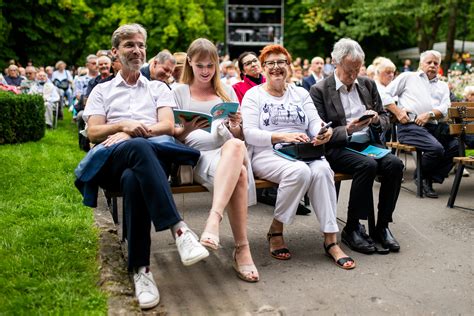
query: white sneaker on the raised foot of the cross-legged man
176 227 209 266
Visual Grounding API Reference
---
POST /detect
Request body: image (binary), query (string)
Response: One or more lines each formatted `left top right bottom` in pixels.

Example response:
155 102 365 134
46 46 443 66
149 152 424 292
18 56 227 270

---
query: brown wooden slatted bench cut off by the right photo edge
448 102 474 208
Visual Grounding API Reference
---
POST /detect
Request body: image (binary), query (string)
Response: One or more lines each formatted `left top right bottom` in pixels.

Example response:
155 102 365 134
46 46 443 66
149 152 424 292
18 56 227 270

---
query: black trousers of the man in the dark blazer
326 144 403 223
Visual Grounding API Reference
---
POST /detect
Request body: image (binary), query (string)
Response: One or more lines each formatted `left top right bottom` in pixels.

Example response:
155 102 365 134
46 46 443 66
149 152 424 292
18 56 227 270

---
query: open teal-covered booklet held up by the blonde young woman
173 102 239 132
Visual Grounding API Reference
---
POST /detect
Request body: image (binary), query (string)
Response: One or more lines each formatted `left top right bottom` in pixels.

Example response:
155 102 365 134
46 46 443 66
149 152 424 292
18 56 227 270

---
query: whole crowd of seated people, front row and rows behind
4 24 474 309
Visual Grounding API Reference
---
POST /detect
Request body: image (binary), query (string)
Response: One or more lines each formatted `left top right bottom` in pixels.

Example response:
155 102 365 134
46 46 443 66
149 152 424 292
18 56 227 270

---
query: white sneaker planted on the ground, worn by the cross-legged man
133 267 160 309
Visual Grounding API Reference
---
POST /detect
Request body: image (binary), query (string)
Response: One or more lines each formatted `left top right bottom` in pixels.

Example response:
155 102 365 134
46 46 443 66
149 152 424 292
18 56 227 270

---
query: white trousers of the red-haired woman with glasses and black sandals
252 149 339 233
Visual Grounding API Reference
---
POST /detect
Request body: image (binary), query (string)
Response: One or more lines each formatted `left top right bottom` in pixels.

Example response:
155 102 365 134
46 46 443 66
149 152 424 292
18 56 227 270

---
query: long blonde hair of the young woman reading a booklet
181 38 231 102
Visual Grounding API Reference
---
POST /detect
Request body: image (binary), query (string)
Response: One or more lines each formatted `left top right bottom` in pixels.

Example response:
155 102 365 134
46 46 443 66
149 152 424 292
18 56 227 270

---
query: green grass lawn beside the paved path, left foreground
0 113 107 315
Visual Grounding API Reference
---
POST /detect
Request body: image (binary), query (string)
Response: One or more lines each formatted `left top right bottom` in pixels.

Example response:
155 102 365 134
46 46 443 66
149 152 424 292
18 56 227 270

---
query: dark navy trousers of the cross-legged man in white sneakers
98 138 181 270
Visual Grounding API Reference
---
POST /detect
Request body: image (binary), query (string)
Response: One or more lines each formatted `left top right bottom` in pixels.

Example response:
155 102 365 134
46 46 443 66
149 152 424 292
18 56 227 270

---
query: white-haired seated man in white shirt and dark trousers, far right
386 50 458 198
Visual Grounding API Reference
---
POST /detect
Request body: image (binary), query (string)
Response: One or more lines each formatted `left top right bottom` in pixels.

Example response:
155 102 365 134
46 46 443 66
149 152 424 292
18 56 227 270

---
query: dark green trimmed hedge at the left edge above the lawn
0 92 46 144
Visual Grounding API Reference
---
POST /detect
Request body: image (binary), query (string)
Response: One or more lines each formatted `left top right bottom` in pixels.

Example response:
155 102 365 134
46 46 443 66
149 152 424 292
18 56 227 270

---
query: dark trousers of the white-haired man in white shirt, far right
397 123 458 183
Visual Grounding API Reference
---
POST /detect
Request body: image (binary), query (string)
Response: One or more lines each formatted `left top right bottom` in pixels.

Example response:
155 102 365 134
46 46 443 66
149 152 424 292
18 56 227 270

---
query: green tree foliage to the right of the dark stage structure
303 0 474 62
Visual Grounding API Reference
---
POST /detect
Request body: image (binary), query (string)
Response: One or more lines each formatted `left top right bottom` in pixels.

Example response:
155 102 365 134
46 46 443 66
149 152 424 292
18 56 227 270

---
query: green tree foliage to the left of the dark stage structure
0 0 225 66
